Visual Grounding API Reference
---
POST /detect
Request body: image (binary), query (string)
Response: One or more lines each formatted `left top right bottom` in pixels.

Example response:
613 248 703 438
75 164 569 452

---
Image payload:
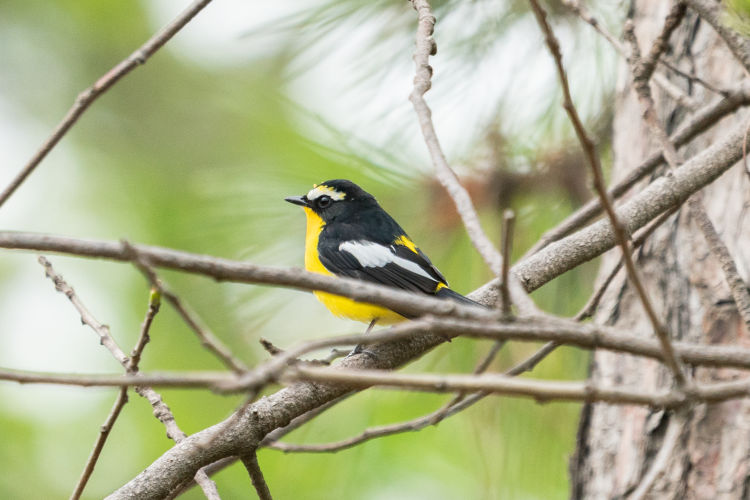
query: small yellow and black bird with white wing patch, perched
286 179 479 331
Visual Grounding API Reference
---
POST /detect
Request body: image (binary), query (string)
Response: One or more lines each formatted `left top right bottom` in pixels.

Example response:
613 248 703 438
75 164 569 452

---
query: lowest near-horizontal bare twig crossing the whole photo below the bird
0 362 750 408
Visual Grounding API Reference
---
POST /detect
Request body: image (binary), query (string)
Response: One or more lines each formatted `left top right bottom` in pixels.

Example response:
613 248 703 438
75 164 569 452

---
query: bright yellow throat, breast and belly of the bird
303 207 406 324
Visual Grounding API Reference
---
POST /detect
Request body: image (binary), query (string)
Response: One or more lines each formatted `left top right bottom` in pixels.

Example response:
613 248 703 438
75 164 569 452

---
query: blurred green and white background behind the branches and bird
0 0 622 499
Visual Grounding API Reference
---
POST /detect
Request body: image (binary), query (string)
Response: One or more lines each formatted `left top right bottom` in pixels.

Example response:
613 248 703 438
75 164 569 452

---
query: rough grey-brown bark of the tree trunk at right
571 0 750 499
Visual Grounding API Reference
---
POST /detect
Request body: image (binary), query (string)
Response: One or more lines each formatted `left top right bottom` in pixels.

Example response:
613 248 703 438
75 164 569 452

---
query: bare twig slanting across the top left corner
0 0 211 207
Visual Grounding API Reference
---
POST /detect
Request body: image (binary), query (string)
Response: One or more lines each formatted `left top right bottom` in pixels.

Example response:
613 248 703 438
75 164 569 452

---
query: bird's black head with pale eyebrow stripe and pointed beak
285 179 377 222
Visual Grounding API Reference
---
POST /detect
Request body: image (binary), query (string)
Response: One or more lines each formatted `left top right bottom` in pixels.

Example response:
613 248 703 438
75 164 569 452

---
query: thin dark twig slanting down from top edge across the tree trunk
529 0 686 386
